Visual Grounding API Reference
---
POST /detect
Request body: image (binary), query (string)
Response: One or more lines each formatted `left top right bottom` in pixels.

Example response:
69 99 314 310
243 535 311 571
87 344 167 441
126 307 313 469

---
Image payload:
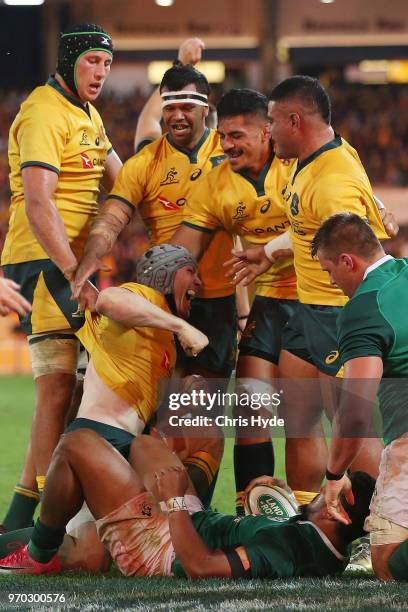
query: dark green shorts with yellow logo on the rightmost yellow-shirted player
282 304 342 376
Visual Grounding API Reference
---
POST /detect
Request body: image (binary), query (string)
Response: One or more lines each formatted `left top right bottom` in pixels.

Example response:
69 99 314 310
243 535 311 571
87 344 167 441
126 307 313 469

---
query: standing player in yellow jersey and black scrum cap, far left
1 24 121 529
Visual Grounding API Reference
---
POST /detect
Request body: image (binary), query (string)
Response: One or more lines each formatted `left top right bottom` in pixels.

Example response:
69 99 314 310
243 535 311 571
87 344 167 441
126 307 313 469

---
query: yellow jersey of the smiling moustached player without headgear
184 157 297 299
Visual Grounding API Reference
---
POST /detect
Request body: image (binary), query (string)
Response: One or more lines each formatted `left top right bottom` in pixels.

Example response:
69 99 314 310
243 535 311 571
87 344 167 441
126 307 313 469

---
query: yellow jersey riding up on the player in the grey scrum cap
77 283 176 423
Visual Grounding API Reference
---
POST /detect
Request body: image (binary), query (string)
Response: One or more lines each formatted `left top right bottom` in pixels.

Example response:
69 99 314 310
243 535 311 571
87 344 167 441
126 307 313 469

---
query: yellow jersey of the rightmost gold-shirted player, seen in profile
283 136 388 306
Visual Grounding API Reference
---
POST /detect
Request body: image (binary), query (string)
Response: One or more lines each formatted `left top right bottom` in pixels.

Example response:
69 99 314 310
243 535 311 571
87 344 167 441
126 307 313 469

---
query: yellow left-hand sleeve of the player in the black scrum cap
16 104 67 172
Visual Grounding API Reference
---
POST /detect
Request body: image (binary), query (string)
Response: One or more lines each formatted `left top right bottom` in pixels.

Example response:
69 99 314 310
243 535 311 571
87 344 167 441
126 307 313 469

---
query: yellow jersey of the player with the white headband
110 128 234 298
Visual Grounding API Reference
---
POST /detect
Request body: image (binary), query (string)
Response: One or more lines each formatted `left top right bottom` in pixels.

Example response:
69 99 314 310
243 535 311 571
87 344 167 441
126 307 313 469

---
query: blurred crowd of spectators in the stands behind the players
0 84 408 287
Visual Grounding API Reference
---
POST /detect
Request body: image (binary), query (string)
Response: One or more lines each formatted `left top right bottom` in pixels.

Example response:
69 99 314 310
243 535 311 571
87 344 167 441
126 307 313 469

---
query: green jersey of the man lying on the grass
172 510 350 578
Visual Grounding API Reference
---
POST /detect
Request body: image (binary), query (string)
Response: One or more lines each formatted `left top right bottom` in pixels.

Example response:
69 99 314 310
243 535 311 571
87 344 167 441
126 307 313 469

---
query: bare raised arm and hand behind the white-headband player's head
134 38 205 151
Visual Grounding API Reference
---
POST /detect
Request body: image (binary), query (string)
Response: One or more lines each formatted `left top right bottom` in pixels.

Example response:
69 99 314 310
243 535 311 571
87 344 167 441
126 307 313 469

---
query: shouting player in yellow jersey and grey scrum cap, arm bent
66 244 223 510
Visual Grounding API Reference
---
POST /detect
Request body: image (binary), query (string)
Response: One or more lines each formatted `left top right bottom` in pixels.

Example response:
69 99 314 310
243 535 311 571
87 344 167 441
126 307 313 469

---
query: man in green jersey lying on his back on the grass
0 429 374 578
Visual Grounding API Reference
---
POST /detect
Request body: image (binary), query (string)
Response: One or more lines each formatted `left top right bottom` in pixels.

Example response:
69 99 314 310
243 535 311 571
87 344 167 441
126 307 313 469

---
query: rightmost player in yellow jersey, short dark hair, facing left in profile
226 76 388 504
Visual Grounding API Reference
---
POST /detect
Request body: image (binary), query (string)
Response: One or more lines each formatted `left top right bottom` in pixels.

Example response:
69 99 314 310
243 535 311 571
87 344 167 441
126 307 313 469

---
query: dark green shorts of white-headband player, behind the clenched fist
176 294 237 378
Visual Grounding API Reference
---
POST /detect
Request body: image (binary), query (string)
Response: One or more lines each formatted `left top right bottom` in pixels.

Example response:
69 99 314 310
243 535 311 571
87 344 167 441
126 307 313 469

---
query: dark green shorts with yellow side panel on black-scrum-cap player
3 259 84 335
